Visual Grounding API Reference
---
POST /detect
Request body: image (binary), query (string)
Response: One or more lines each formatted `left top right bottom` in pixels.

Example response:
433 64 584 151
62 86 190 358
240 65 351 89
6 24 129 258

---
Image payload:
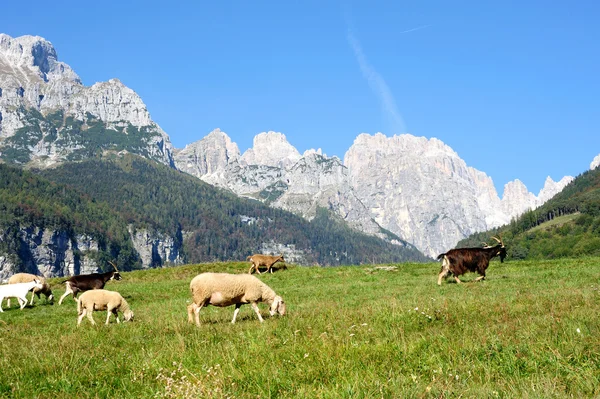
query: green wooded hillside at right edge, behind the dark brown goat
457 168 600 259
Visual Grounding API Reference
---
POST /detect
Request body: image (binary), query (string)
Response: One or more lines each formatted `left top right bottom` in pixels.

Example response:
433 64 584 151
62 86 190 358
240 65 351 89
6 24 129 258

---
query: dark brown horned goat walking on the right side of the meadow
437 237 506 285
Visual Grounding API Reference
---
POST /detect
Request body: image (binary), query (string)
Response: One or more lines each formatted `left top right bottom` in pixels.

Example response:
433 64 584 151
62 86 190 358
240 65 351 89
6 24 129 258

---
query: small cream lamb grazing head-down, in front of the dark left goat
77 289 133 326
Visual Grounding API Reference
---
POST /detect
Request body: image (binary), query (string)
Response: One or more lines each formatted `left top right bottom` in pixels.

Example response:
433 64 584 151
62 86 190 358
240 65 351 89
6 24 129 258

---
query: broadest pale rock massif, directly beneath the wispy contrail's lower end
344 134 508 256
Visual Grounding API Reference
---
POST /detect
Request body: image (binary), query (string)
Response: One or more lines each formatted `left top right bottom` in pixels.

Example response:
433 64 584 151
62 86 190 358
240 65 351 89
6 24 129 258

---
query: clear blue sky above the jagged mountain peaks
0 0 600 195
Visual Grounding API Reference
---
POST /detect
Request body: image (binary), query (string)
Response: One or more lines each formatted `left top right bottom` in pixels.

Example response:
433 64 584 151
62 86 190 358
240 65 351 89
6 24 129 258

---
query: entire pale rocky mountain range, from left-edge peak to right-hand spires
0 34 600 266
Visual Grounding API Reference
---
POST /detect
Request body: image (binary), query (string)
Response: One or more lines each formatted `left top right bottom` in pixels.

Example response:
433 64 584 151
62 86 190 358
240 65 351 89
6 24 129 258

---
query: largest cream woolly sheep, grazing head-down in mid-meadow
187 273 285 326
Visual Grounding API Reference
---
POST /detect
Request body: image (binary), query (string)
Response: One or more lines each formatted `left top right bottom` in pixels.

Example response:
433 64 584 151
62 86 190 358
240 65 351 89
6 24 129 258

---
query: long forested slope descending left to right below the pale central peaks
25 155 426 265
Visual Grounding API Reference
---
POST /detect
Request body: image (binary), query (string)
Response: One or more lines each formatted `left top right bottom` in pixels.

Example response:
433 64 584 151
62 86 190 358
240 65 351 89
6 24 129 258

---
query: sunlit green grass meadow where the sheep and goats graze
0 258 600 399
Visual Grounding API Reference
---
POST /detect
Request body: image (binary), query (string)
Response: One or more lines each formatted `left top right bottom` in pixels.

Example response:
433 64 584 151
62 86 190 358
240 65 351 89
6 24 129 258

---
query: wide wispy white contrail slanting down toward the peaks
348 28 408 134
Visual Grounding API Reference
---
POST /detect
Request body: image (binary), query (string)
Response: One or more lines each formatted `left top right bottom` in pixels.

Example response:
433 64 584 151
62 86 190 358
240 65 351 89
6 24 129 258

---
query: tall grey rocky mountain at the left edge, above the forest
0 34 173 167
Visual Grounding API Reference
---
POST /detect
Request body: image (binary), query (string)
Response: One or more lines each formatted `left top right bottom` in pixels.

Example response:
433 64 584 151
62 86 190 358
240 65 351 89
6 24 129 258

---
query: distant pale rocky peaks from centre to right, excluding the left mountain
175 129 573 256
